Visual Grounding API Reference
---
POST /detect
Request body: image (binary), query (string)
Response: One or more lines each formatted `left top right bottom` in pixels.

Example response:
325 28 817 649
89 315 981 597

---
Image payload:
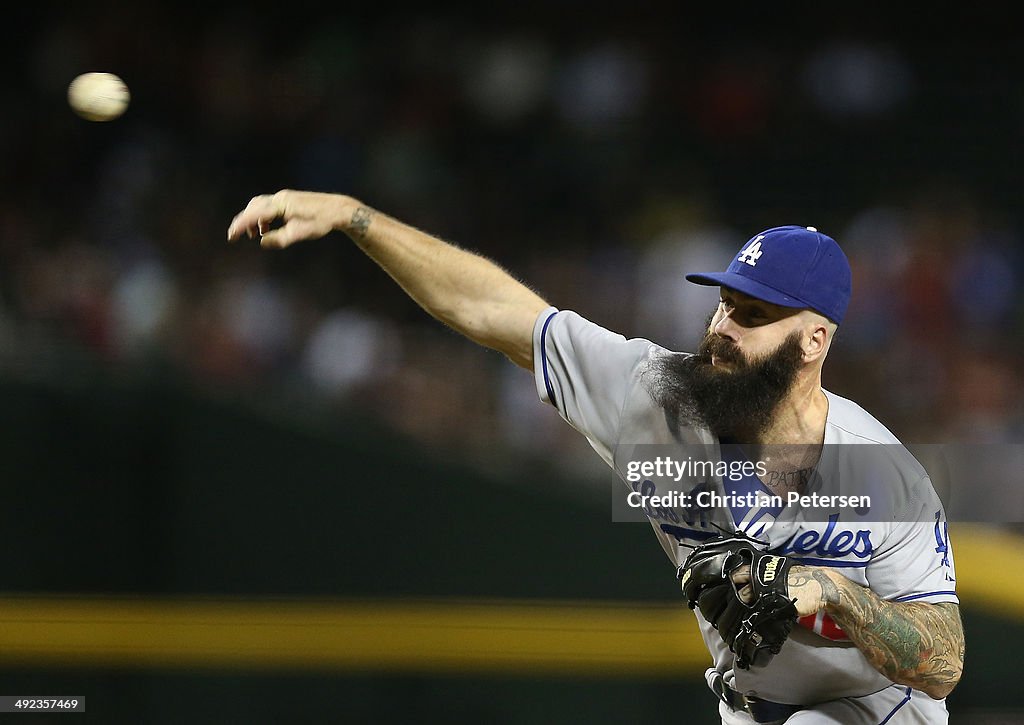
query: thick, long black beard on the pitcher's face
649 332 803 442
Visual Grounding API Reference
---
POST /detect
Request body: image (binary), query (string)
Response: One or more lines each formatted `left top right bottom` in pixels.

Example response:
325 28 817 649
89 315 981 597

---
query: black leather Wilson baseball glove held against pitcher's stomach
678 531 797 670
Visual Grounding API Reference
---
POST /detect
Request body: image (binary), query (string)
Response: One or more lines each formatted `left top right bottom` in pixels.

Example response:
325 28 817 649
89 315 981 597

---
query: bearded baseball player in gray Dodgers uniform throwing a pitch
227 190 964 725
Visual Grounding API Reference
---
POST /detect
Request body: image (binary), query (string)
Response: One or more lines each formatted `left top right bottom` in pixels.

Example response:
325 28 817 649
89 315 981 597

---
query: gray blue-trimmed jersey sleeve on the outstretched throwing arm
534 307 659 466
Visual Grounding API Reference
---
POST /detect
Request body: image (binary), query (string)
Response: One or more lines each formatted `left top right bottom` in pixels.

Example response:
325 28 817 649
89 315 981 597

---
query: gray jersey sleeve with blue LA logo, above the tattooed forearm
866 478 959 604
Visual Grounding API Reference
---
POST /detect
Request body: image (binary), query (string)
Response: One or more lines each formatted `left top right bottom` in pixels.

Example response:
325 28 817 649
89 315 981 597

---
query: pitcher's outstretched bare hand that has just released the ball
227 189 349 249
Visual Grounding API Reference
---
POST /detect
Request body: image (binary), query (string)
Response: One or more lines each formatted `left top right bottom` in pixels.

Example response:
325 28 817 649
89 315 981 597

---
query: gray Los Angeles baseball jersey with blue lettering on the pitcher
534 307 958 715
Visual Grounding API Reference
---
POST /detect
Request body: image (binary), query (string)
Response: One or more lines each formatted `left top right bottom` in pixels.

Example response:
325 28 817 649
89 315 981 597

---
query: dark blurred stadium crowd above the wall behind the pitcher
0 7 1024 493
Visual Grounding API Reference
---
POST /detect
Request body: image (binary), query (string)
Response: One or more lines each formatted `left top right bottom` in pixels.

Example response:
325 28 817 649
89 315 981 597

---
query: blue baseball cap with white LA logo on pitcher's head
686 225 852 325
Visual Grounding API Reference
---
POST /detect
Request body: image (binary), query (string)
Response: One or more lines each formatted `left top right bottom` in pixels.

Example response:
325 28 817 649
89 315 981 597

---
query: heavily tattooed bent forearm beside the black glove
815 571 964 692
